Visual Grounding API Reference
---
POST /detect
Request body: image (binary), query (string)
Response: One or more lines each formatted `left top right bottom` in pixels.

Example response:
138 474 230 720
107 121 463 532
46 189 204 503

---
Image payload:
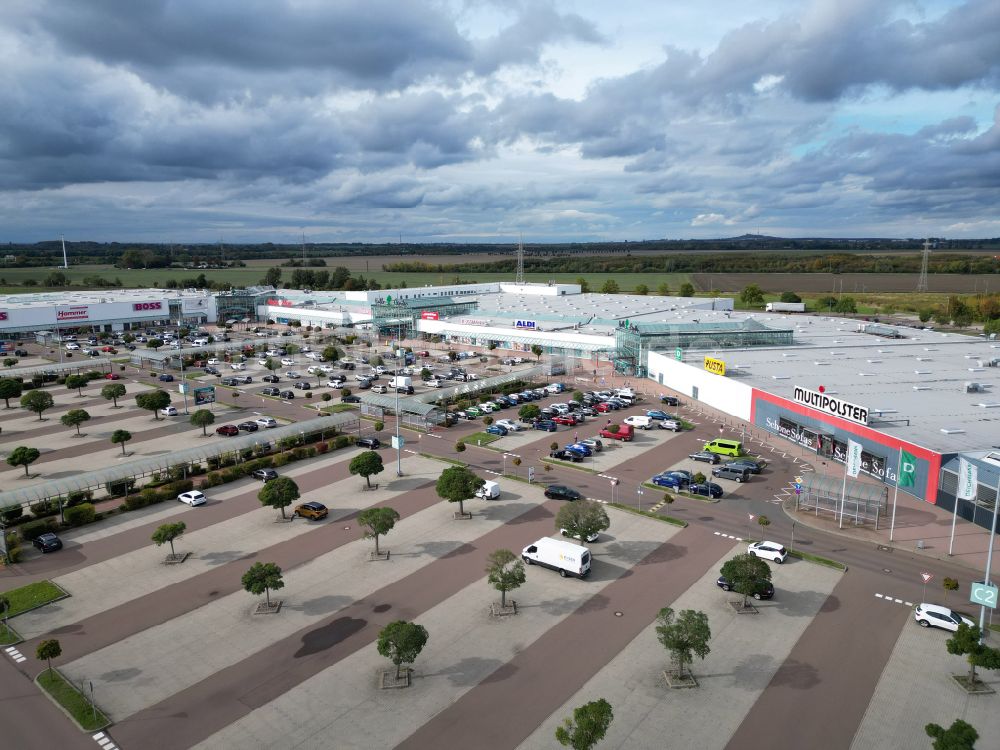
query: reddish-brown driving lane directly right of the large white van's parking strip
398 526 731 748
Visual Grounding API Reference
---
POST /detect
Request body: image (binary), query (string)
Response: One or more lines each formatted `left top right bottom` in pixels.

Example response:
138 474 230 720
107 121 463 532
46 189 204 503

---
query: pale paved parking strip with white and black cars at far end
520 556 841 750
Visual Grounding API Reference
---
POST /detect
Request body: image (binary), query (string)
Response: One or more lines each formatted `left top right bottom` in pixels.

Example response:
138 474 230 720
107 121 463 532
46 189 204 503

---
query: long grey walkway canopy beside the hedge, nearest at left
0 412 358 509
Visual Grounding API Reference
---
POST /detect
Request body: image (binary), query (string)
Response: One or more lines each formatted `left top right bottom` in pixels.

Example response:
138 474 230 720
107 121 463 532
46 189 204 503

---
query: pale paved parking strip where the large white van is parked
192 509 679 750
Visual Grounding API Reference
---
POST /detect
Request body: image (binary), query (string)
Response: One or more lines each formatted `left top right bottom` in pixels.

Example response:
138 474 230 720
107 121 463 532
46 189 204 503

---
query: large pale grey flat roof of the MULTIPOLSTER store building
671 313 1000 453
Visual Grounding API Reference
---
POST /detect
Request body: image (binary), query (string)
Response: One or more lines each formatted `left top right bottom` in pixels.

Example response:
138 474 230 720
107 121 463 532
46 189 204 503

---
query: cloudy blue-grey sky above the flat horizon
0 0 1000 243
